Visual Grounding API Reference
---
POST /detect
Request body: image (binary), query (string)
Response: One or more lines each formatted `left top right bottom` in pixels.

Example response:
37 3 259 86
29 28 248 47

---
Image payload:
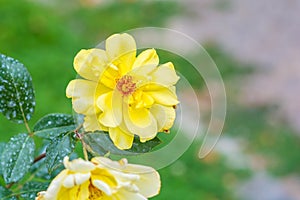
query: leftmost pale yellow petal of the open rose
66 79 97 114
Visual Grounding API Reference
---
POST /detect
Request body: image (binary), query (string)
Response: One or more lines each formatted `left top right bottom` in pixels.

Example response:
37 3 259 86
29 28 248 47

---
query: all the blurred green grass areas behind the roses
0 0 300 200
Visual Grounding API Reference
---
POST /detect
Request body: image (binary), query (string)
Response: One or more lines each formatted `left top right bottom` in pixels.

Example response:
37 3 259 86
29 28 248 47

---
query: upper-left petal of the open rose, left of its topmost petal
73 49 108 81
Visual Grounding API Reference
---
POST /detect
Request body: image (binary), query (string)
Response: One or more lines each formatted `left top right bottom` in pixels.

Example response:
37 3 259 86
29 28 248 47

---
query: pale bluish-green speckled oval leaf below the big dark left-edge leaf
1 133 35 184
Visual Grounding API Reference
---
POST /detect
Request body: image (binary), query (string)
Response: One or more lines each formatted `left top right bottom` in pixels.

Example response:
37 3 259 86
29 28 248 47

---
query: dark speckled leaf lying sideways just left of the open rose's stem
33 113 76 139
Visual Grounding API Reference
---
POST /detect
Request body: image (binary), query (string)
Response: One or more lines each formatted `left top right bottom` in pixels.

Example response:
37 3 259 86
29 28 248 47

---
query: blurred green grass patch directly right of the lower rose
153 141 249 200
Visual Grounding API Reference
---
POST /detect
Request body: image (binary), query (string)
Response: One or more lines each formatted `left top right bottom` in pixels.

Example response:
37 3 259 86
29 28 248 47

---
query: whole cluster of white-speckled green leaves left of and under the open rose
0 54 160 200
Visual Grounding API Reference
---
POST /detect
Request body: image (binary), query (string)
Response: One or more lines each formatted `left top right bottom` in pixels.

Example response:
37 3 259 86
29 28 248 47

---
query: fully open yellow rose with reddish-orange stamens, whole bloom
66 33 179 149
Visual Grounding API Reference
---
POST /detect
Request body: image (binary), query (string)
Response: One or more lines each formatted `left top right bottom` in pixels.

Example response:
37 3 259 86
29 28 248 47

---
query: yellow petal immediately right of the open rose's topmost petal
132 49 159 69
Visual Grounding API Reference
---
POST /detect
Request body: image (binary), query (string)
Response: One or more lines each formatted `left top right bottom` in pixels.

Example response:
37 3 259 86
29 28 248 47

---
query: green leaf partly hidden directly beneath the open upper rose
83 132 161 155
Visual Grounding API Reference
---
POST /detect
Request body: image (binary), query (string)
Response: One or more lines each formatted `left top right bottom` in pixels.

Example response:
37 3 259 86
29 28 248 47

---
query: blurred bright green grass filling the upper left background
0 0 179 141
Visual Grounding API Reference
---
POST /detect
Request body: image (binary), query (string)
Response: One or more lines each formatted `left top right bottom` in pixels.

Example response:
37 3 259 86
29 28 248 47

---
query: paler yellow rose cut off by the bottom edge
36 157 160 200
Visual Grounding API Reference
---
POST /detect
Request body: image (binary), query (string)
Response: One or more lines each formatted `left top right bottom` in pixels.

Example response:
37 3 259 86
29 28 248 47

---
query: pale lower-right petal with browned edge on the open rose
150 104 176 132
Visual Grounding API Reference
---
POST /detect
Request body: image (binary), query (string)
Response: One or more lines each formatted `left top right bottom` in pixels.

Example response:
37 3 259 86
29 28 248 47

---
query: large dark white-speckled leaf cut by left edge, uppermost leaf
0 54 35 123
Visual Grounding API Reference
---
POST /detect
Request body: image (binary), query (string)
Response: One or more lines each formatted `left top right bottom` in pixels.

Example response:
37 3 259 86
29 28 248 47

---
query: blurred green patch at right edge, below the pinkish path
225 102 300 176
